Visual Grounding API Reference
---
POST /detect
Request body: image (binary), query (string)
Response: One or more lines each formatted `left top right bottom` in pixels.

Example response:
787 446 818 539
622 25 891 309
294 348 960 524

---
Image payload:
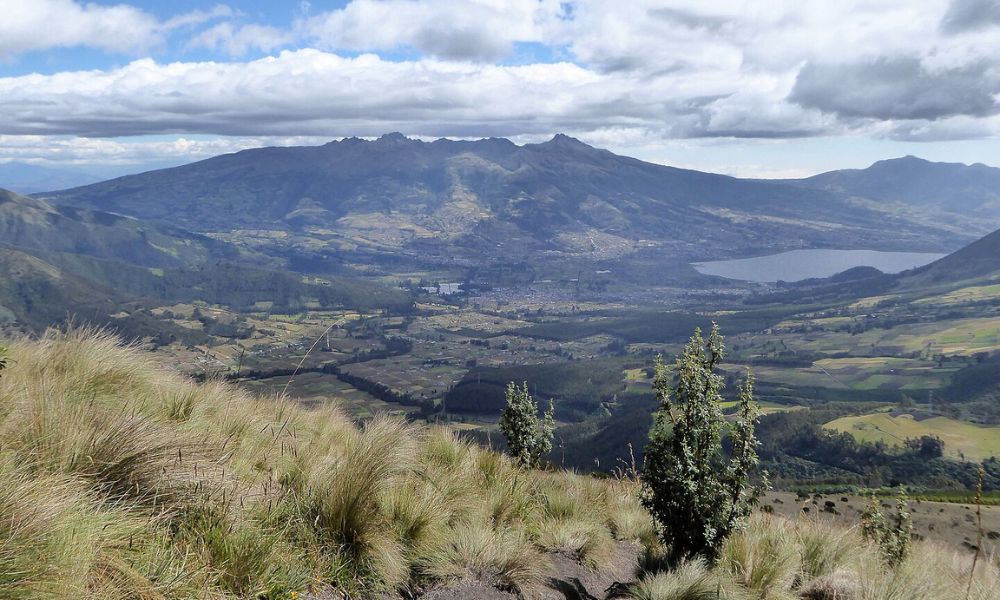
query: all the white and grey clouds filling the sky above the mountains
0 0 1000 146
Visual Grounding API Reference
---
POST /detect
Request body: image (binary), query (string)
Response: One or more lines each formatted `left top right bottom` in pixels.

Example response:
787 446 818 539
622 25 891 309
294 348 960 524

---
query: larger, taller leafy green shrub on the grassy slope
642 324 767 564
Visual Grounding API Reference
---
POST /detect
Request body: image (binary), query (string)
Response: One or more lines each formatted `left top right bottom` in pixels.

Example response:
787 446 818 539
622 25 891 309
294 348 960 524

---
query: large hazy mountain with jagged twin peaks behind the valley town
44 134 970 264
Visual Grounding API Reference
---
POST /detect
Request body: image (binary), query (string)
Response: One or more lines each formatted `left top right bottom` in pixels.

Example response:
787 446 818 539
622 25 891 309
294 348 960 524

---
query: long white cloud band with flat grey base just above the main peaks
0 50 832 137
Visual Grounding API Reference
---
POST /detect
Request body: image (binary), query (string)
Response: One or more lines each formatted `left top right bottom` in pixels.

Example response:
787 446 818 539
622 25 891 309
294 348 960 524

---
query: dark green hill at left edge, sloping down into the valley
0 190 411 332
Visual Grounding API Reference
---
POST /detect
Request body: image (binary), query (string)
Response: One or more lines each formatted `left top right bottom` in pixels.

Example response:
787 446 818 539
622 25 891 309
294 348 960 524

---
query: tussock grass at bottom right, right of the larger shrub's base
630 515 1000 600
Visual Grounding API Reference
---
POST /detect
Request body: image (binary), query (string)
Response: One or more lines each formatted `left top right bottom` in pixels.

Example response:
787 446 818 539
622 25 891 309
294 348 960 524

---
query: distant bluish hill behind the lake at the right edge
783 156 1000 235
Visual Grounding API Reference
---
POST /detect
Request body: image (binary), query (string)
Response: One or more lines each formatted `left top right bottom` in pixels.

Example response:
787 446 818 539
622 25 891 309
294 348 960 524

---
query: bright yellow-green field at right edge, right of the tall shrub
824 413 1000 460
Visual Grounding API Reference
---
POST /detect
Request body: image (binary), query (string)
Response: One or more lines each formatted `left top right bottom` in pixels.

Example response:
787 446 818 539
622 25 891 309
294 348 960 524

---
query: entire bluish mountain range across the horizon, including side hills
0 134 1000 336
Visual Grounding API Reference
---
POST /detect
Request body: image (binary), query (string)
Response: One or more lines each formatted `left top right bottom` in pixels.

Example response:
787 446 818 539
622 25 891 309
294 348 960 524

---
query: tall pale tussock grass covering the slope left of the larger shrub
0 329 643 600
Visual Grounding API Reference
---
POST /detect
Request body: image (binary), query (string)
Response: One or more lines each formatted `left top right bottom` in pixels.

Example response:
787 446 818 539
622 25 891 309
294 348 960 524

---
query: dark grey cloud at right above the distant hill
789 58 1000 120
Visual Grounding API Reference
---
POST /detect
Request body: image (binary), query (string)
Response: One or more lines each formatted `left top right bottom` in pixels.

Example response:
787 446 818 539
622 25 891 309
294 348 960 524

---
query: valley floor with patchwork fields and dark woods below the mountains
119 245 1000 490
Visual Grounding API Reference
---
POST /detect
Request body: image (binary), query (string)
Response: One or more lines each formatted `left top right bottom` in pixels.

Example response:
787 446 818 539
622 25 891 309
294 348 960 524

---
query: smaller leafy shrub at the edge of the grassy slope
500 382 555 468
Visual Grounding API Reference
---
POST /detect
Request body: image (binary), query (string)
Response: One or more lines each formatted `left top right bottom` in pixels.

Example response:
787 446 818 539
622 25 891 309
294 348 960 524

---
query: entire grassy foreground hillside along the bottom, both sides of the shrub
0 331 1000 600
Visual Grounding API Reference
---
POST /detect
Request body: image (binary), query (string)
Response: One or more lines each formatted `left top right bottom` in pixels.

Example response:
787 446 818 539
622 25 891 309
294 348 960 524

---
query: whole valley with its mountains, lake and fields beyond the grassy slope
0 134 1000 491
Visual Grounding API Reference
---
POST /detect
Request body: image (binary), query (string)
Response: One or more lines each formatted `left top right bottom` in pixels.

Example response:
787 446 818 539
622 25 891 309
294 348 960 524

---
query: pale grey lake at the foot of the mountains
692 250 945 283
